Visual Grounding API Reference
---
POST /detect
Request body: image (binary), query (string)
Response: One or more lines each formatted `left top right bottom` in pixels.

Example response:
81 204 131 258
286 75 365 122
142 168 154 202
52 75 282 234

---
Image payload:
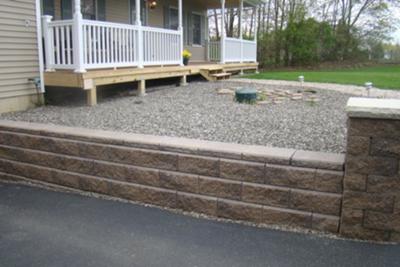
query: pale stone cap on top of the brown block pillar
346 97 400 120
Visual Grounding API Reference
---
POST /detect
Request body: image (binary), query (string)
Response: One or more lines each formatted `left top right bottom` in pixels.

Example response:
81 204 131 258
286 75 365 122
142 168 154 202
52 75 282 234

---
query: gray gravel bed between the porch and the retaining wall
0 82 351 152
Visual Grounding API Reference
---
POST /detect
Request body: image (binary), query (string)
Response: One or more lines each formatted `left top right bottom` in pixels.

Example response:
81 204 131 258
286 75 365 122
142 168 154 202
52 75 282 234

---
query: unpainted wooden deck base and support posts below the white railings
44 63 258 106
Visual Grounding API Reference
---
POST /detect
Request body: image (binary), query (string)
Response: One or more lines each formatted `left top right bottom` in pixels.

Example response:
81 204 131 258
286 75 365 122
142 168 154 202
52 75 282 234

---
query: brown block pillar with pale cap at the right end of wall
340 98 400 242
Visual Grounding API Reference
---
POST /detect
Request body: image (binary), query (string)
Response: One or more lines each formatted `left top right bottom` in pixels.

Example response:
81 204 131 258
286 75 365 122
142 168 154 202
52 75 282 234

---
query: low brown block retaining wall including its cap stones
0 121 344 233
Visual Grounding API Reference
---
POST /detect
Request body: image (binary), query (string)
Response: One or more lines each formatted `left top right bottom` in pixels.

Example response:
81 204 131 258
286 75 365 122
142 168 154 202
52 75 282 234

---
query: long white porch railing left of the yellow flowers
43 16 182 70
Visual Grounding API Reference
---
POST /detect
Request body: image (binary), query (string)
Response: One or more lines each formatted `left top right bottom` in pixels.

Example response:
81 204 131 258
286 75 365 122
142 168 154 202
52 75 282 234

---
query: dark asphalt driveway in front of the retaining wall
0 183 400 267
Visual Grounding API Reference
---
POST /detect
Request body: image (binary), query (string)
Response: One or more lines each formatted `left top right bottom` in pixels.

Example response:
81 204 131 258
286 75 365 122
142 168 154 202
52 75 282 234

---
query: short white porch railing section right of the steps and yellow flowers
208 37 257 63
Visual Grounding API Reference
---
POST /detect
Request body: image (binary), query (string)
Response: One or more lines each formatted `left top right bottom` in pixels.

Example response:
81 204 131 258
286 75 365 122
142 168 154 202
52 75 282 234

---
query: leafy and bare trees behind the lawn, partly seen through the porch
210 0 400 67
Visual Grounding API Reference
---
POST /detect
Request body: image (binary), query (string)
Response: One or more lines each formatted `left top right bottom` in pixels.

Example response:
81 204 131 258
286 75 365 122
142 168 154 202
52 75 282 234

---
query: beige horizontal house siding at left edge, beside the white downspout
0 0 40 113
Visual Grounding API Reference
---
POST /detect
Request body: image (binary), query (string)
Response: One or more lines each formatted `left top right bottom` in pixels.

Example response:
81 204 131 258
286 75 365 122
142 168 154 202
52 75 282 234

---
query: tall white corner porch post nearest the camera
72 0 86 72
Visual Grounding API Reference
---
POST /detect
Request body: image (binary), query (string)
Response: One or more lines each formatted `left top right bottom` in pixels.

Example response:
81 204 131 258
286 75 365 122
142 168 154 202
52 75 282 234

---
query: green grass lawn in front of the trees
246 65 400 90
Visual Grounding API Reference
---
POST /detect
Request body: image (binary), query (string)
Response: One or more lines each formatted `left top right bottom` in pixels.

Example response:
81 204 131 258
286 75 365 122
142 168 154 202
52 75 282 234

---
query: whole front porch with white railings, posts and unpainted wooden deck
42 0 259 105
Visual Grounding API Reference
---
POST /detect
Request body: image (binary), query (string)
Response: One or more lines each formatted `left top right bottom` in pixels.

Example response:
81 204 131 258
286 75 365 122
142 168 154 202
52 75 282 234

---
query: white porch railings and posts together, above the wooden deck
42 0 259 72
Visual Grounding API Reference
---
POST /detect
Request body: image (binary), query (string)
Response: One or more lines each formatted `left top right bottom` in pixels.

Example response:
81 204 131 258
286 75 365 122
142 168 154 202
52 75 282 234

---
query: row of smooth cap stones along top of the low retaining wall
0 120 344 170
